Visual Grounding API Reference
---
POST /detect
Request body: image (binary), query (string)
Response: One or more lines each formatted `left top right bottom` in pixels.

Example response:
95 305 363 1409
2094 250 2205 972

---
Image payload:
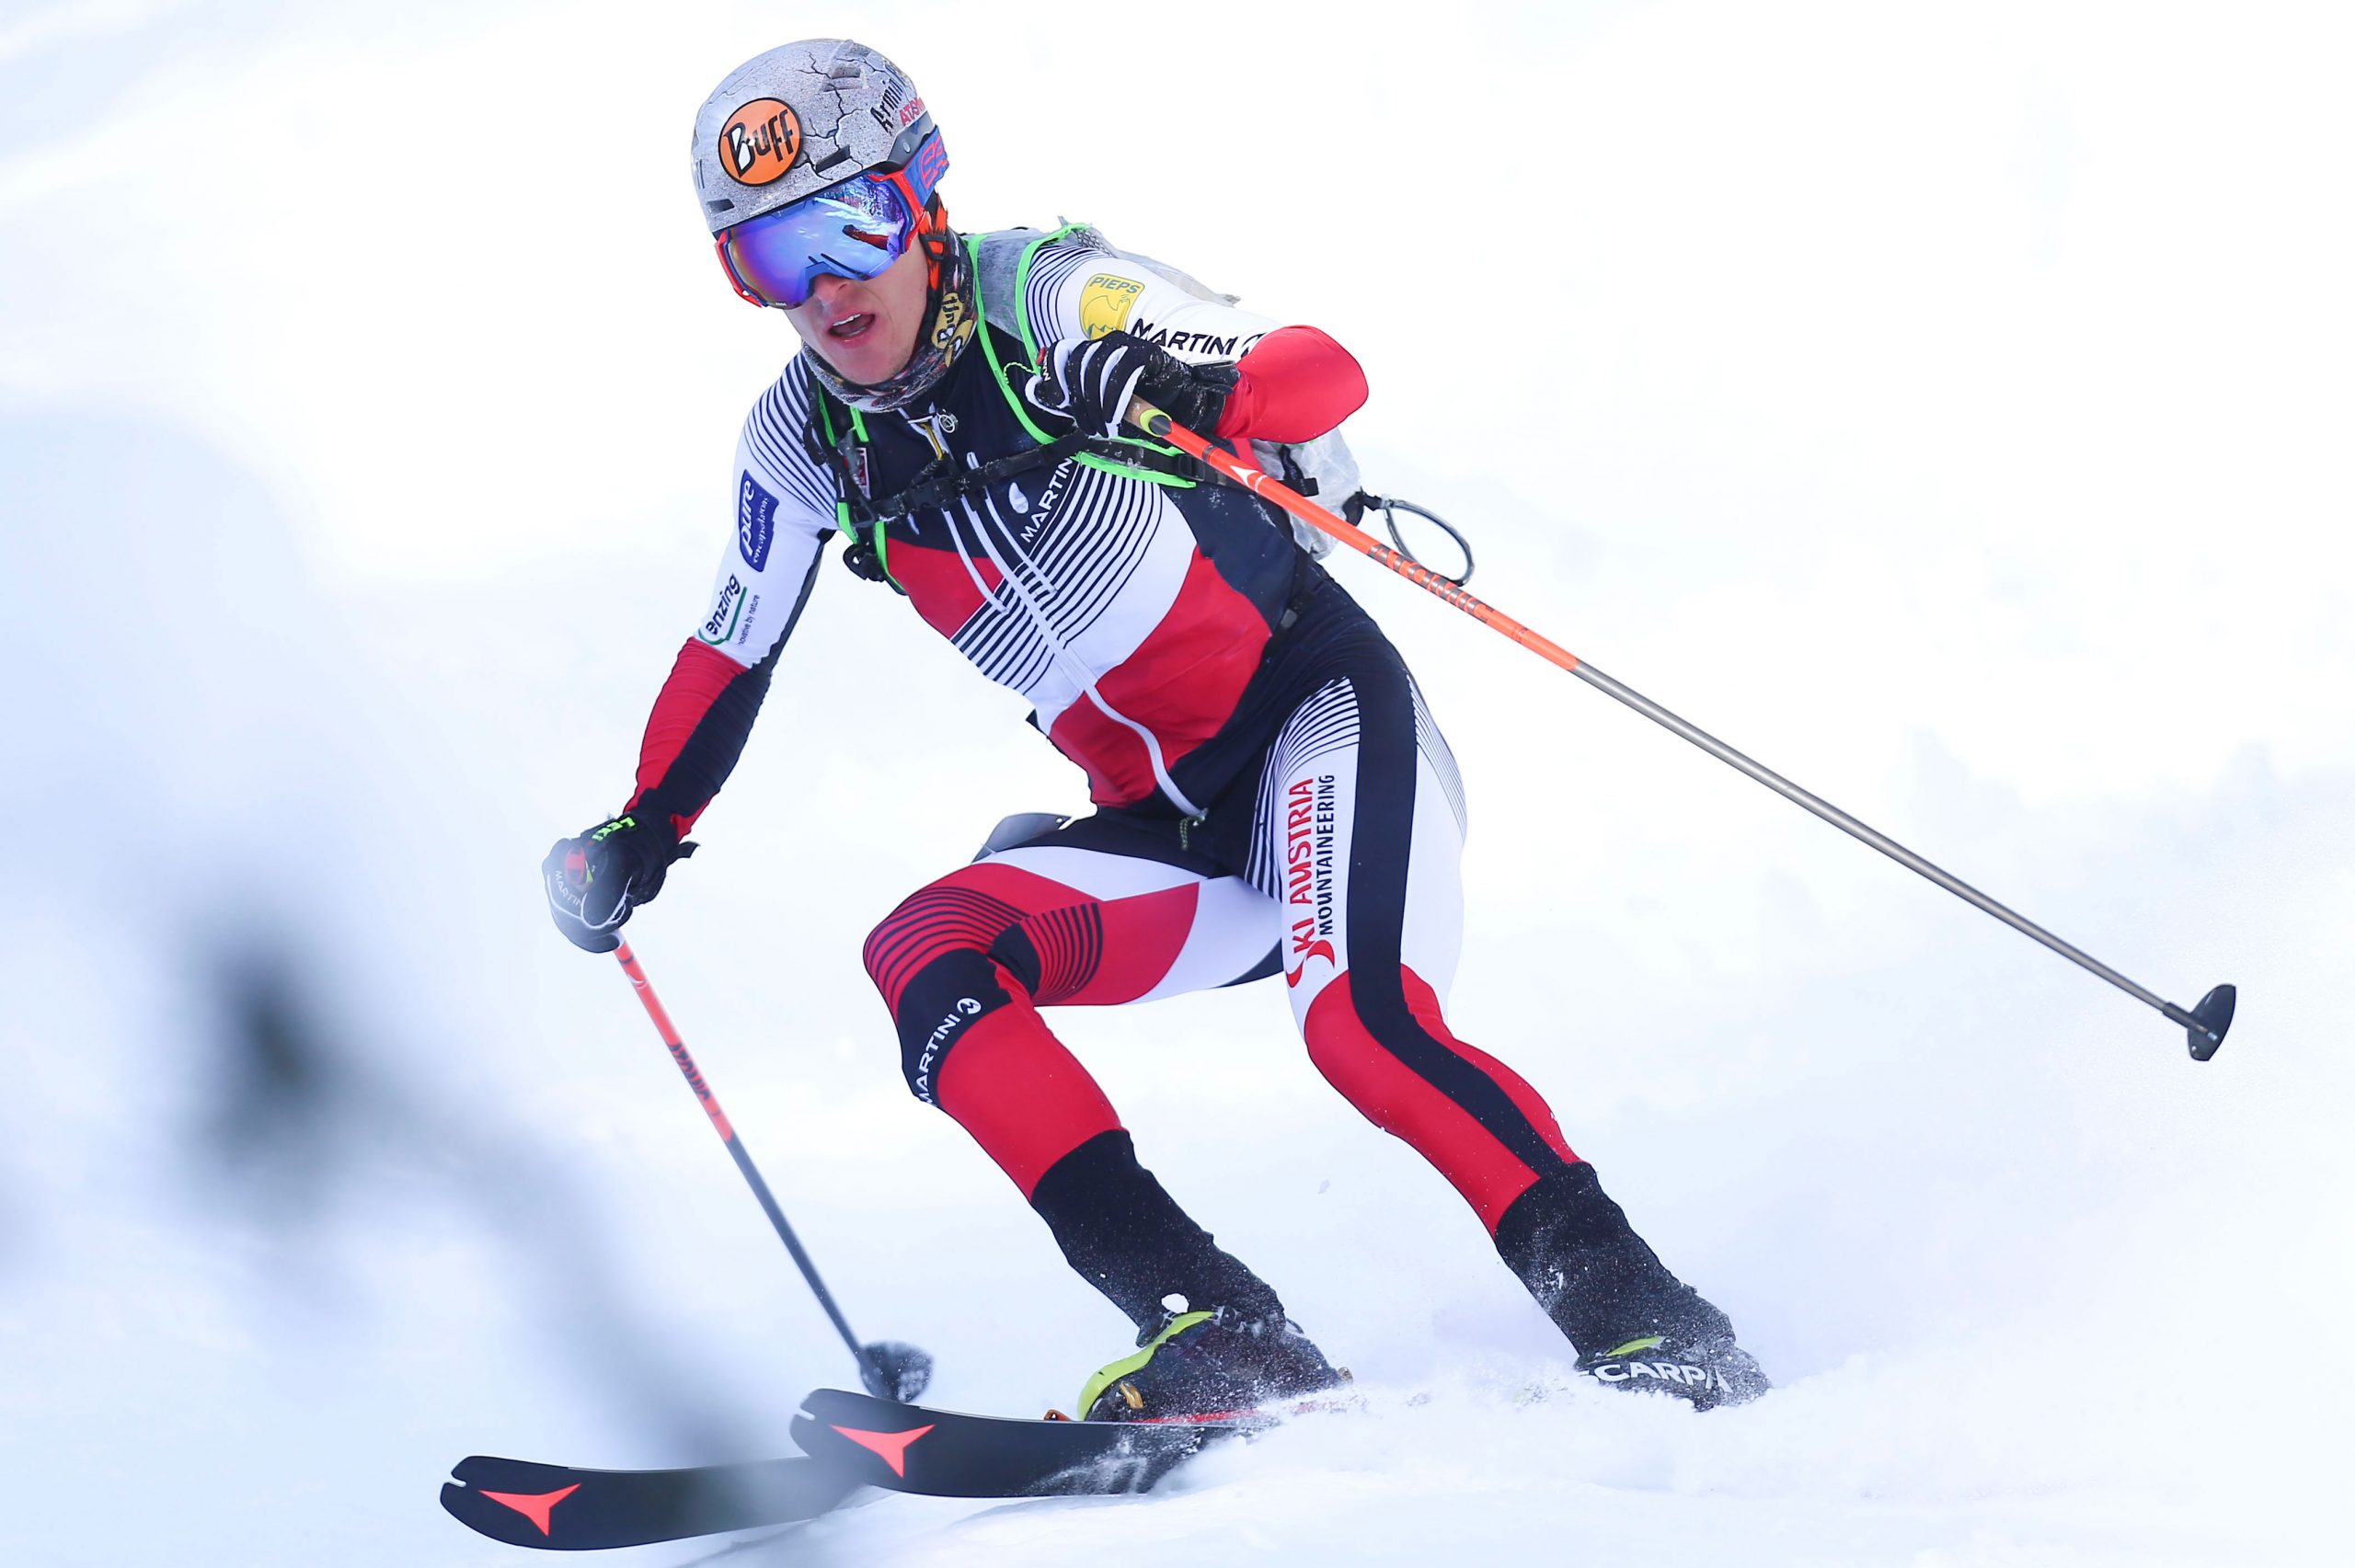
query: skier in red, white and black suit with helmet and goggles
544 38 1769 1420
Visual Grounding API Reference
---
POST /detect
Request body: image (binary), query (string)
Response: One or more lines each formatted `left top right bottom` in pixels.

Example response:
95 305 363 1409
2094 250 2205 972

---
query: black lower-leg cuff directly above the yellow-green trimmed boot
1031 1130 1283 1328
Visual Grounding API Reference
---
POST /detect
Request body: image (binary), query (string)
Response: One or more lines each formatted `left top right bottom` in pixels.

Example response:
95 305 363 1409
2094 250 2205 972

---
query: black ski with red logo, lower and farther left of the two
442 1455 857 1551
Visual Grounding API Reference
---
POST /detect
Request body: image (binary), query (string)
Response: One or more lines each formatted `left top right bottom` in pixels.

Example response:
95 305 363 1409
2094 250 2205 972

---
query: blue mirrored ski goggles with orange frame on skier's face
714 132 949 308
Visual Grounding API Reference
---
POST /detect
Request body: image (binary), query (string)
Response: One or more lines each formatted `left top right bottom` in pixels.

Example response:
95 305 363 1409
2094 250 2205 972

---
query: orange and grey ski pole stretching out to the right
1123 398 2234 1062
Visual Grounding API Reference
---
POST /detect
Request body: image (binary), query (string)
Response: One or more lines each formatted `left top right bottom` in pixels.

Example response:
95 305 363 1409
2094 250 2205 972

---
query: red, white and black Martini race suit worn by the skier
631 231 1685 1323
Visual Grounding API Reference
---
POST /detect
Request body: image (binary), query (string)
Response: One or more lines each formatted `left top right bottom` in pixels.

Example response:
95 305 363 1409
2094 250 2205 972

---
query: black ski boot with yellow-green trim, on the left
1078 1295 1350 1422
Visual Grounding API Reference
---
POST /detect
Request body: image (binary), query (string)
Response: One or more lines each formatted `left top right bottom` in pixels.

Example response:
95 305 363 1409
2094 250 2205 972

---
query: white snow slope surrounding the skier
0 0 2355 1568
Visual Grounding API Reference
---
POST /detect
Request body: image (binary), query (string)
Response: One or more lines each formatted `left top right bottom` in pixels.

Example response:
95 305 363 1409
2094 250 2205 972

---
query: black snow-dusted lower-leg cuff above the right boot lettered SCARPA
1496 1163 1733 1354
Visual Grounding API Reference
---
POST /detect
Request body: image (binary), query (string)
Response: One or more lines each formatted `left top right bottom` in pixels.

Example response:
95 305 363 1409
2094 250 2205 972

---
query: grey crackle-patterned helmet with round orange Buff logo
695 38 947 233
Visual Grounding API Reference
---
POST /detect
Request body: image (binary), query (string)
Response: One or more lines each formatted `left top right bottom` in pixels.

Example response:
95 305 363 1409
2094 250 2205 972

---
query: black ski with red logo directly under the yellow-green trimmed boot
794 1389 1267 1497
